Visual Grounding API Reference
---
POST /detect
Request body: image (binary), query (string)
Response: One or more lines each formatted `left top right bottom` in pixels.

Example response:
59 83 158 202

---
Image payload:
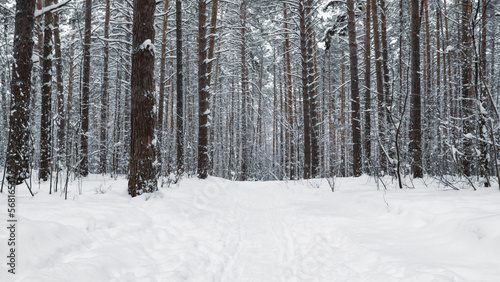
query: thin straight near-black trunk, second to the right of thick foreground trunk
176 0 184 177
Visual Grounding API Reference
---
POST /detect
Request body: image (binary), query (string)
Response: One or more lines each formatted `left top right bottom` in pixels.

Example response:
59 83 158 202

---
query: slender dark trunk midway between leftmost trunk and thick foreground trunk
79 0 92 177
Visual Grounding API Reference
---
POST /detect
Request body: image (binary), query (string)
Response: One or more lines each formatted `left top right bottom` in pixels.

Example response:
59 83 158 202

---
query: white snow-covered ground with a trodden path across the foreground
0 176 500 282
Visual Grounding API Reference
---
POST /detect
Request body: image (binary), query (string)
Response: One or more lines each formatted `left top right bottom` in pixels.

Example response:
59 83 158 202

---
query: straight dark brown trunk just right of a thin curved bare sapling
409 0 423 178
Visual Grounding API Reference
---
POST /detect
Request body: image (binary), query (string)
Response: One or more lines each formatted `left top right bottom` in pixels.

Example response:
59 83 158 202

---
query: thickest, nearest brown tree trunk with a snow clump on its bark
128 0 158 197
